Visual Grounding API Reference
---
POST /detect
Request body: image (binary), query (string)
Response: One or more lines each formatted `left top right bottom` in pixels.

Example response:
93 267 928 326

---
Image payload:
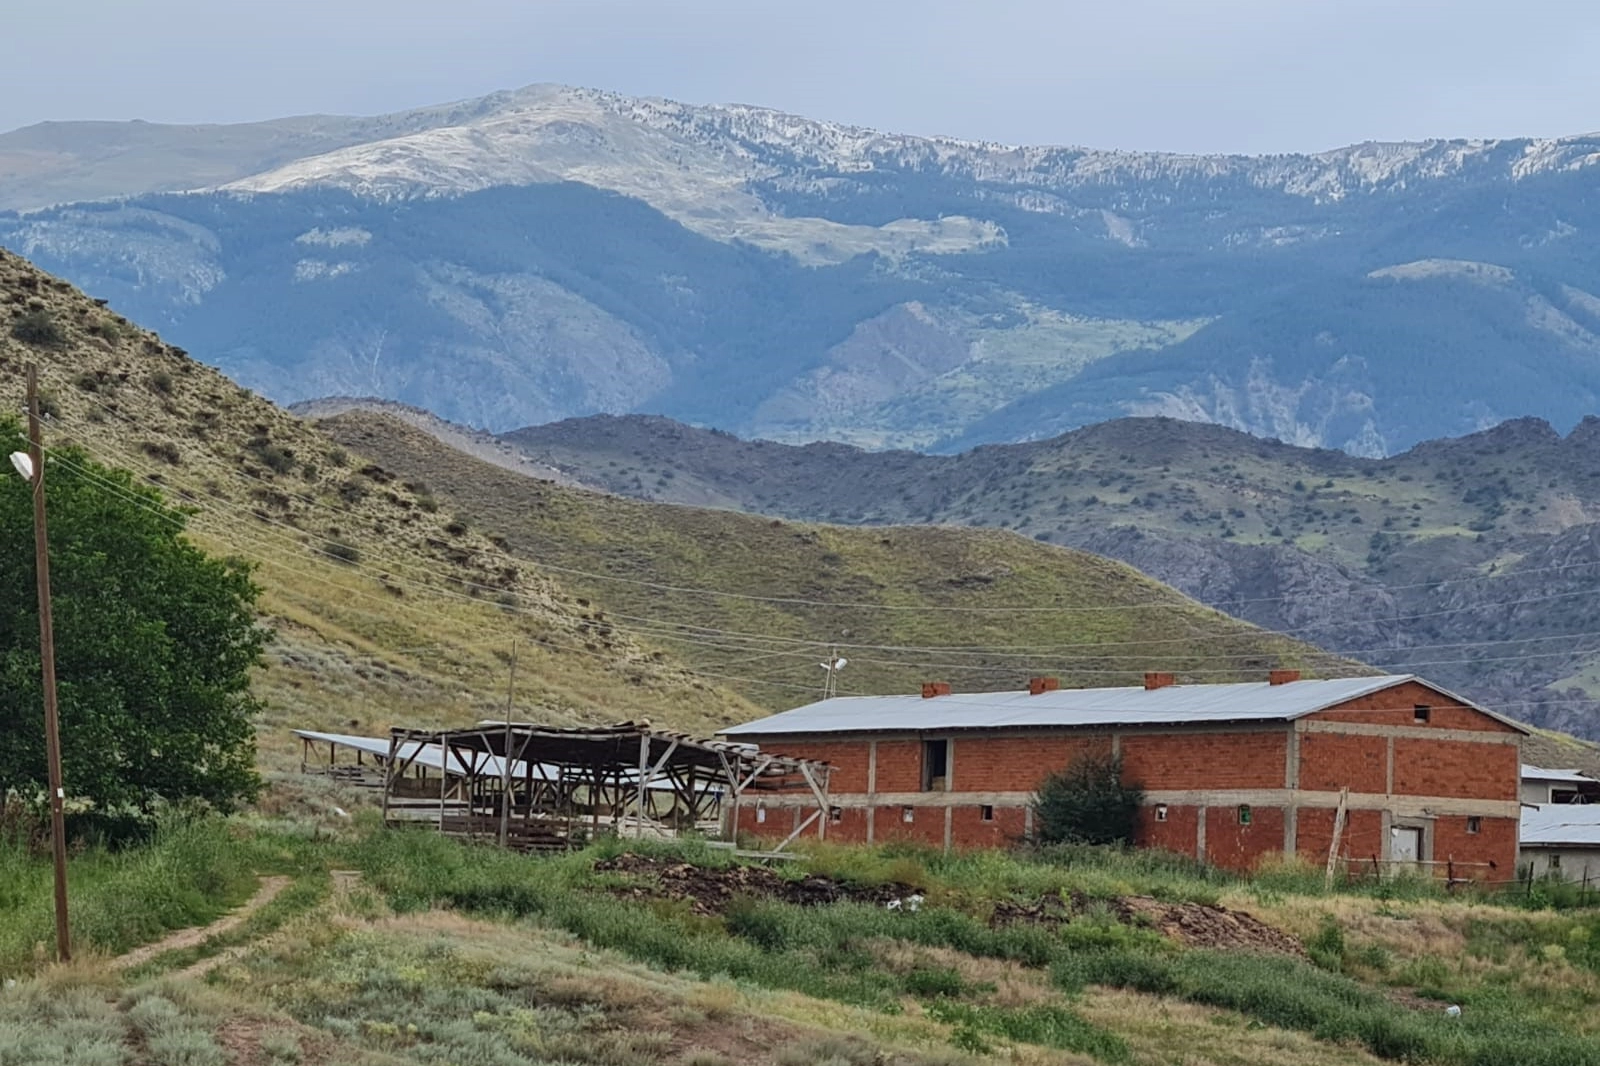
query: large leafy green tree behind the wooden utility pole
0 419 267 821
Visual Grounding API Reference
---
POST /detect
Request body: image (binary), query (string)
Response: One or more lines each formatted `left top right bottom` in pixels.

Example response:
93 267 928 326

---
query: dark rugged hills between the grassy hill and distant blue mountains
504 416 1600 735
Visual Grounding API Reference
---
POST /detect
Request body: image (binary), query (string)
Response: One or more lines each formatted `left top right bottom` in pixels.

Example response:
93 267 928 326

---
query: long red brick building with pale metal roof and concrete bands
725 671 1526 877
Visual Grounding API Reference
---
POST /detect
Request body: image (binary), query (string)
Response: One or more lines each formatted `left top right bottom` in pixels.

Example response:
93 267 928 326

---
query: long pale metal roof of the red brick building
723 674 1526 736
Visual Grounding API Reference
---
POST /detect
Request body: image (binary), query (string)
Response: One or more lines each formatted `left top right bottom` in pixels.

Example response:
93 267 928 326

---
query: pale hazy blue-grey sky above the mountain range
12 0 1600 152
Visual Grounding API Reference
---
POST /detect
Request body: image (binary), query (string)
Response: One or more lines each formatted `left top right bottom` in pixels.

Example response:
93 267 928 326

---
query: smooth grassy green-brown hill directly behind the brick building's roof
308 411 1358 706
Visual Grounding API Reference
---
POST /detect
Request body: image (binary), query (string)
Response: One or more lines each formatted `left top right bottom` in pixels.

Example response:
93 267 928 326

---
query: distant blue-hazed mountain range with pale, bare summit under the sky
0 86 1600 456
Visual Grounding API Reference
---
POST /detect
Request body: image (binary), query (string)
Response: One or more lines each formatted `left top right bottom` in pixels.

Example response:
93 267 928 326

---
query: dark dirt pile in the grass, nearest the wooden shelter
595 852 917 914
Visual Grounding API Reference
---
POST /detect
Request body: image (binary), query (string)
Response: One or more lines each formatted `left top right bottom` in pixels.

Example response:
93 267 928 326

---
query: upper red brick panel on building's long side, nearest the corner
1122 727 1288 791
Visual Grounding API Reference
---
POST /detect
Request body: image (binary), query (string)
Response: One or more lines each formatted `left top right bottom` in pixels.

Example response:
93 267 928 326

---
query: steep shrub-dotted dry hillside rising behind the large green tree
0 251 757 760
